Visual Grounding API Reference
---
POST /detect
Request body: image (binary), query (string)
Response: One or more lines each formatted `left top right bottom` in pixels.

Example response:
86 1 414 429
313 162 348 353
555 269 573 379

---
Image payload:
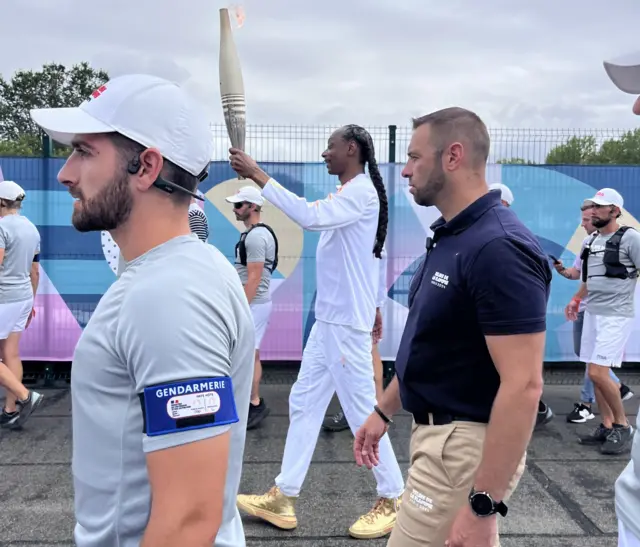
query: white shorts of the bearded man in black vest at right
580 311 633 367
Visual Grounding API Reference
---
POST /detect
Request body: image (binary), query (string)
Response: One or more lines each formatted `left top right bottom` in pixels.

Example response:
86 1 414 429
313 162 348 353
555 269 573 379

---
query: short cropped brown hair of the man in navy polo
413 107 491 167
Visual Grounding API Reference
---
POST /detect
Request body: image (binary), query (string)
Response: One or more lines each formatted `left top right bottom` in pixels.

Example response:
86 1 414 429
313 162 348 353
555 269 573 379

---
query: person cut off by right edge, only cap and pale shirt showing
605 54 640 547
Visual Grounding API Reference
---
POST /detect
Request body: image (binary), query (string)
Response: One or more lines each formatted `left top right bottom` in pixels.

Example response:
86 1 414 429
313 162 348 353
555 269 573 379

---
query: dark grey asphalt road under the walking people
0 375 640 547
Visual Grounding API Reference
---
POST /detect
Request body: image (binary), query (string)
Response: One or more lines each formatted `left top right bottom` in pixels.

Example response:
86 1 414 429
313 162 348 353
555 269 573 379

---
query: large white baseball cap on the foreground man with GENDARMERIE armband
31 74 213 176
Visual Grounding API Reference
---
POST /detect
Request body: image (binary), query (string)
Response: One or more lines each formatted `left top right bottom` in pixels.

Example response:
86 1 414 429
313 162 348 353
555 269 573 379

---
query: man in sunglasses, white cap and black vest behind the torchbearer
226 186 278 429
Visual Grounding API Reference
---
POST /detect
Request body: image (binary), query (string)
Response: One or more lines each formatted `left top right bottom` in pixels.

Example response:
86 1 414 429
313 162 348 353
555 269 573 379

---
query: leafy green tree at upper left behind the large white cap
0 63 109 155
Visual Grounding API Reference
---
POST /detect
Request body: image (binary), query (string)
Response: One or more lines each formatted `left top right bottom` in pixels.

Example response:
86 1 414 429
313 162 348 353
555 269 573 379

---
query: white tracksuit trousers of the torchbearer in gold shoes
276 321 404 498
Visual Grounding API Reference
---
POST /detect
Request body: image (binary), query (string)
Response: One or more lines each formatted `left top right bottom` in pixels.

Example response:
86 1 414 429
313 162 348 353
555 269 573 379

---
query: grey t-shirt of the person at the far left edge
0 215 40 304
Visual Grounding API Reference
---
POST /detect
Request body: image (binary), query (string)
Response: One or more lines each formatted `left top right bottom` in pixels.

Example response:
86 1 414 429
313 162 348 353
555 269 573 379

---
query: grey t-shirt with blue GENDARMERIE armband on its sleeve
71 235 255 547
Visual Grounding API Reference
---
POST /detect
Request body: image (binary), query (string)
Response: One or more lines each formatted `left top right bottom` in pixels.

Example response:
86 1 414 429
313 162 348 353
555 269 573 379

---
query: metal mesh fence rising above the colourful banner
205 124 628 164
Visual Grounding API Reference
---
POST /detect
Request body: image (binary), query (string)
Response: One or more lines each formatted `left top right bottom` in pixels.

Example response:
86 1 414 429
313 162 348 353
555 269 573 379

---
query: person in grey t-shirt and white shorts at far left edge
0 180 42 429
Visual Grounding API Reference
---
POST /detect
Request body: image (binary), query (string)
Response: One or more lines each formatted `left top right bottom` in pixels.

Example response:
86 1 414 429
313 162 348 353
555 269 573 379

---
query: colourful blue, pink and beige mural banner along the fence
0 157 640 362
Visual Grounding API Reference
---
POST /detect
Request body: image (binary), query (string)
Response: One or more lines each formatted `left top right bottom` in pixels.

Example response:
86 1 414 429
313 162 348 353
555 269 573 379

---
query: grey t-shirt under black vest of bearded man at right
587 228 640 317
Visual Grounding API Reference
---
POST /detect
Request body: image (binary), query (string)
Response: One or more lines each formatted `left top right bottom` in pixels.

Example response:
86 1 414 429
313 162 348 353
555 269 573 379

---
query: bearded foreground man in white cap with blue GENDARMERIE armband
31 75 254 547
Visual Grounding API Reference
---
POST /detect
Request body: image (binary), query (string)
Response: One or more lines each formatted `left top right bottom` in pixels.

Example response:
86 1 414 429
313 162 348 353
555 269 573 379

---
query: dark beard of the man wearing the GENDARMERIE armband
71 171 133 232
